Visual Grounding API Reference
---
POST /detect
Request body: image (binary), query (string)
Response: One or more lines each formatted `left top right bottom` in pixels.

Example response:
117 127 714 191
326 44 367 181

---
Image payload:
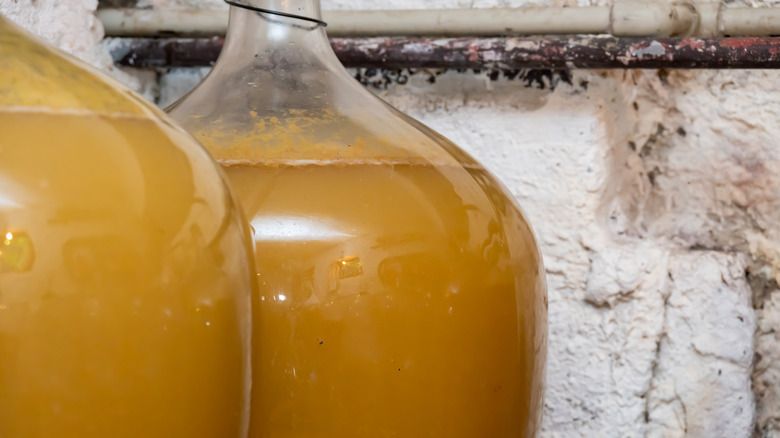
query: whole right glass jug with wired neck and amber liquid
169 0 547 438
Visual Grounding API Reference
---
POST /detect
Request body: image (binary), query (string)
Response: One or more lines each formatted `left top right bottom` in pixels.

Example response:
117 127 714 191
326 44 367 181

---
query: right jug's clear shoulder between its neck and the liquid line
166 63 476 164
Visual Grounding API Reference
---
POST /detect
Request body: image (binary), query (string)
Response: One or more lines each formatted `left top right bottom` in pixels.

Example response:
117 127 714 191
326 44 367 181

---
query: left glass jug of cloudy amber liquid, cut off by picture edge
0 16 254 438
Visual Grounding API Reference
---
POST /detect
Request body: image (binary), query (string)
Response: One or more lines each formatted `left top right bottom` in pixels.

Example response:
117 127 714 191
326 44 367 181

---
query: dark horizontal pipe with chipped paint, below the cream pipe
107 36 780 70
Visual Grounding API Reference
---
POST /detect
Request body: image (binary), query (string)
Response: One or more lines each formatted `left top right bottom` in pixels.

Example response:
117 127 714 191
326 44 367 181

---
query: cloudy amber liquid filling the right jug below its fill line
226 159 546 438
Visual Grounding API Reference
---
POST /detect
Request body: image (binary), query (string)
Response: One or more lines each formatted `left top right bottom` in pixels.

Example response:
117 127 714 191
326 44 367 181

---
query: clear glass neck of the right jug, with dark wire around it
218 0 340 67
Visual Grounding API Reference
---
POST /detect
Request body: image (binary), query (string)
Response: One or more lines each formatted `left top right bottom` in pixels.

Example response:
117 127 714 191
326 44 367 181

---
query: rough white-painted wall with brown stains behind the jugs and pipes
7 0 780 438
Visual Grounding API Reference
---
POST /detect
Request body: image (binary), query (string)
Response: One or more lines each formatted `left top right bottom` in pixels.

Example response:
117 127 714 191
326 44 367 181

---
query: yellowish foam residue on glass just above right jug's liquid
182 109 470 166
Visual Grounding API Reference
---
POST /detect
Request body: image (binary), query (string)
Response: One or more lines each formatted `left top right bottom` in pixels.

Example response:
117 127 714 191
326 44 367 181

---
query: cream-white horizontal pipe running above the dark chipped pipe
97 0 780 37
